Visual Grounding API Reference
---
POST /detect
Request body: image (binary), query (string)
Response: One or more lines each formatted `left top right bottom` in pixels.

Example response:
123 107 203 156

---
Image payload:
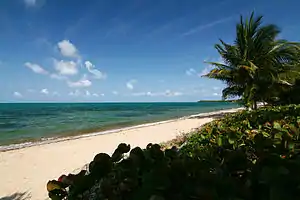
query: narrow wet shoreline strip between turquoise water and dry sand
0 107 244 153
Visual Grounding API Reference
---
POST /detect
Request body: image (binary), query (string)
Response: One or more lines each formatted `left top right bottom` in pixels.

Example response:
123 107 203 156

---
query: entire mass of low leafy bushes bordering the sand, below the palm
47 106 300 200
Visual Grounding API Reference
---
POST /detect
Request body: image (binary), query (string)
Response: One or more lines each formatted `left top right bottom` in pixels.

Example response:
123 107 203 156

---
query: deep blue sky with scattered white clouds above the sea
0 0 300 102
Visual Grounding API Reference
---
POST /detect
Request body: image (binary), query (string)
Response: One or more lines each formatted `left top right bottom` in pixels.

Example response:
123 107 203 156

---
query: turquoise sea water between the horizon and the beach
0 102 238 145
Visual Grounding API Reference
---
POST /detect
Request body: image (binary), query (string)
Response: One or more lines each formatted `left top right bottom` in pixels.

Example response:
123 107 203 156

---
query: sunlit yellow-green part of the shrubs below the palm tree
185 105 300 152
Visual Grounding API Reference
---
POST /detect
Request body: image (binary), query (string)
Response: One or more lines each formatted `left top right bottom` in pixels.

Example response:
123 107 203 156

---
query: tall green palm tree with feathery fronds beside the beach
204 13 300 109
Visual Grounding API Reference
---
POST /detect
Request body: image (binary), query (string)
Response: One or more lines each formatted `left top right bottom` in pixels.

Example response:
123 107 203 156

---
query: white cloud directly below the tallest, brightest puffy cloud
54 59 78 75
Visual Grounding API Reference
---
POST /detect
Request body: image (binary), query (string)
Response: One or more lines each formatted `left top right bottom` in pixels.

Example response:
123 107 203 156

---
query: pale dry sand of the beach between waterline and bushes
0 109 237 200
